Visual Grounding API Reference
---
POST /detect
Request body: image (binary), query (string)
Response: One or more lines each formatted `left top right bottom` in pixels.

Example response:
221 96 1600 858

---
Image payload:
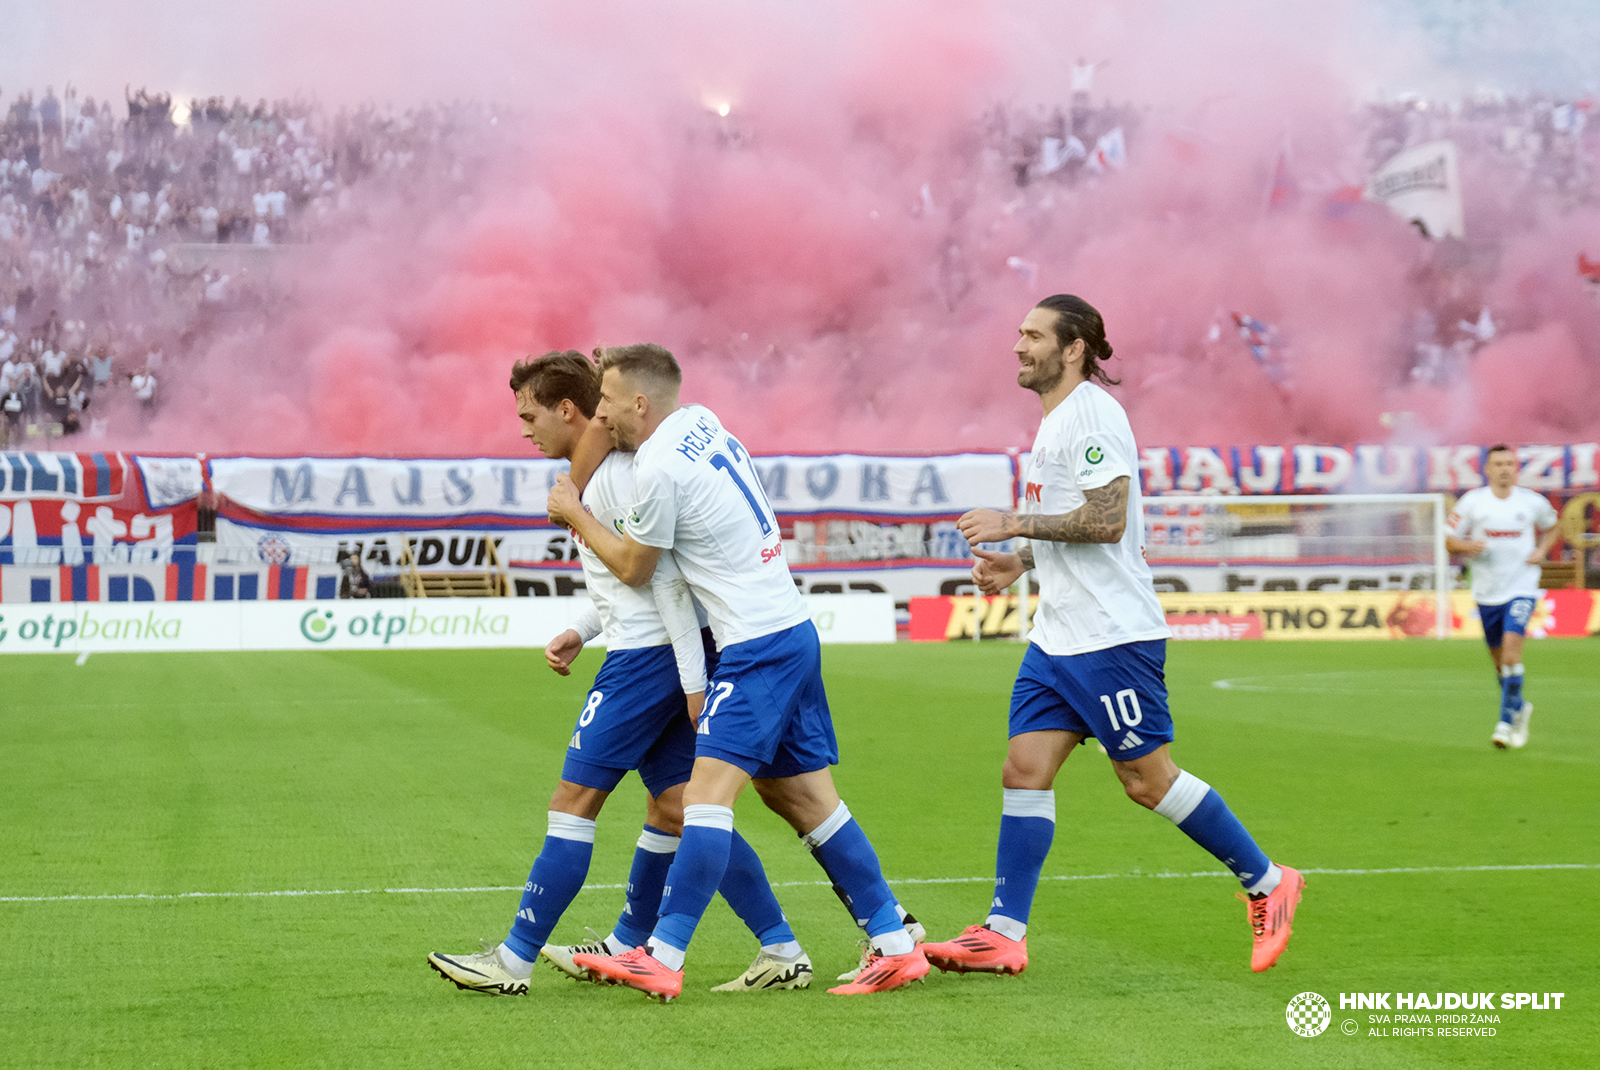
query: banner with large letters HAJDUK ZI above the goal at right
1139 441 1600 494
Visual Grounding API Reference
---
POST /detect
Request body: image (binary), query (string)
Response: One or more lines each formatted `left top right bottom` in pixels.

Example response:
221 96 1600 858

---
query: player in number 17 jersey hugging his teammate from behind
550 344 928 1001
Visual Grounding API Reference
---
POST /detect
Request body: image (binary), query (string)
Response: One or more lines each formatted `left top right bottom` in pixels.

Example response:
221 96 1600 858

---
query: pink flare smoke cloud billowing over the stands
5 0 1600 454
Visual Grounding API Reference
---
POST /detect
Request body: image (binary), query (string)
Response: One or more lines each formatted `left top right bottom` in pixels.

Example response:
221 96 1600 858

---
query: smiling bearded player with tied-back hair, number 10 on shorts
923 294 1306 974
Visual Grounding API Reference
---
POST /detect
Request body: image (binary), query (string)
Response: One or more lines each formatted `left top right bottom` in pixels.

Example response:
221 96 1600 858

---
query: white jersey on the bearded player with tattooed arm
1022 382 1171 656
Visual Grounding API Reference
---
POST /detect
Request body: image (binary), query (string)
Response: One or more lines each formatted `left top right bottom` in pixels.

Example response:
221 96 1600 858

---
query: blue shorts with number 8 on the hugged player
562 629 717 795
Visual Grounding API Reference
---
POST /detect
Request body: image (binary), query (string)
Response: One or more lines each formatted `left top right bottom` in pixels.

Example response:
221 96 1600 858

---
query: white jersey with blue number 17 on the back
624 405 811 649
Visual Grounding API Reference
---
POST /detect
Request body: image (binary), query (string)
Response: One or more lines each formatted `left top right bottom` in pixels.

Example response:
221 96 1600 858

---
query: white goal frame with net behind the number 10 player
1142 494 1454 638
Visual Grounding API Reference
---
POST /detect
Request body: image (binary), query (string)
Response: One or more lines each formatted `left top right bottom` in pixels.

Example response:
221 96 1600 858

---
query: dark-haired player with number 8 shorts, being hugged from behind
427 350 811 995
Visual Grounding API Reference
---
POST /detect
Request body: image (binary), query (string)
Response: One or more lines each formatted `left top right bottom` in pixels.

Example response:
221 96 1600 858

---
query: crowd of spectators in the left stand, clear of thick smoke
0 85 498 445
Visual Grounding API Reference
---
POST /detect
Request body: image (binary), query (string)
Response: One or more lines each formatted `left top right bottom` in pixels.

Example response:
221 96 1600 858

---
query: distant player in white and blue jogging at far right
1445 443 1560 750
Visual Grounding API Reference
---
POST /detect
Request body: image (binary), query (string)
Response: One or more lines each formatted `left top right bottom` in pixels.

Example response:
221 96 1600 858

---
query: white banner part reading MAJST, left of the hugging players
208 457 566 531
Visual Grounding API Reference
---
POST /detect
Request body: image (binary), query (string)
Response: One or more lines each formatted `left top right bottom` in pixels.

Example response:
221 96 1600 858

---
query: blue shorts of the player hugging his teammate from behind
694 621 838 779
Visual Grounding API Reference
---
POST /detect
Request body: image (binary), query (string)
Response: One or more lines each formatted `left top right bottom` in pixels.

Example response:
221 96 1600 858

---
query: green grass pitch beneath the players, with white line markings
0 640 1600 1070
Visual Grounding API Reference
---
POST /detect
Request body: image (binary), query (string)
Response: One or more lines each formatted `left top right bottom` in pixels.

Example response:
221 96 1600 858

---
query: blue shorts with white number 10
1010 640 1173 761
